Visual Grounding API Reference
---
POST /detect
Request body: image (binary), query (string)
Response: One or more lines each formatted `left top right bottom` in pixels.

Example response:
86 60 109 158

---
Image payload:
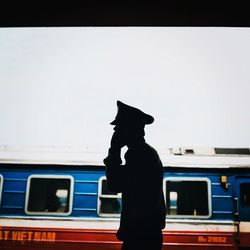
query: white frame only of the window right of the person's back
163 177 212 219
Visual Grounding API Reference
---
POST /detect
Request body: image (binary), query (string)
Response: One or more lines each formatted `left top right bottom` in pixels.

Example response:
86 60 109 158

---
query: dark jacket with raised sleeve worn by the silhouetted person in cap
104 140 166 240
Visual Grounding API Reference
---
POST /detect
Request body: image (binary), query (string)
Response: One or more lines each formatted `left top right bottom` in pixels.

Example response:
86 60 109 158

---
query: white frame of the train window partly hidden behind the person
97 176 122 218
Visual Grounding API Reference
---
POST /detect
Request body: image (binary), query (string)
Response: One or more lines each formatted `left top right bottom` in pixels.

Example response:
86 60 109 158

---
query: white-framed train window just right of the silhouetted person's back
164 178 211 218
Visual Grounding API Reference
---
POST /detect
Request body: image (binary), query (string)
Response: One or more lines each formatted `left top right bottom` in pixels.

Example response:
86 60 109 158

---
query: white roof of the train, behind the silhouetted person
0 148 250 168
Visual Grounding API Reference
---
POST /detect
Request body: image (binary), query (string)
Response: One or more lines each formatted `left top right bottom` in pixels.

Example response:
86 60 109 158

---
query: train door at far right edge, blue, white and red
235 177 250 249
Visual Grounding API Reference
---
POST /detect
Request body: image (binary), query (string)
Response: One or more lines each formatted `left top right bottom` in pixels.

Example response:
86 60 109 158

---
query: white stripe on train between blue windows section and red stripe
0 218 238 232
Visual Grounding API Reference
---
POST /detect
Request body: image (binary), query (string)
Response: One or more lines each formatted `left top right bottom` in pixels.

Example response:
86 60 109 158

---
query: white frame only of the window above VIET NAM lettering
24 174 74 216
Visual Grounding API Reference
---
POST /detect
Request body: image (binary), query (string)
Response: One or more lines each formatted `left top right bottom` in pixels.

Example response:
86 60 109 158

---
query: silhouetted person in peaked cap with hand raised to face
104 101 166 250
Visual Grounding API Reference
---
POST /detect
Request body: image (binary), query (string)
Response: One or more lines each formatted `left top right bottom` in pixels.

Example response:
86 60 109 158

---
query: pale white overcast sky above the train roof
0 27 250 156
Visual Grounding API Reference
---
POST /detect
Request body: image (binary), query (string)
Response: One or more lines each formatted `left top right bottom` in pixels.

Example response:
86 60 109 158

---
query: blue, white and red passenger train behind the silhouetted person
0 148 250 250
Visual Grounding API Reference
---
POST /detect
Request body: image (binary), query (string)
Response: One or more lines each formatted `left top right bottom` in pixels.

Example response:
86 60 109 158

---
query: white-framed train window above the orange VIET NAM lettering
25 175 73 215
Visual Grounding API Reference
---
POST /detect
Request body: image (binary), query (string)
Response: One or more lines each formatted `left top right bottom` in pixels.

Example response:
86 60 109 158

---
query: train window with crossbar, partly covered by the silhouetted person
97 177 122 217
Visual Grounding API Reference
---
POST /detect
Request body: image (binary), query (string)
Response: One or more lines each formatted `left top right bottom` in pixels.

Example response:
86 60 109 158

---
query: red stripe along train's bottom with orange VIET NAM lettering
0 227 250 250
